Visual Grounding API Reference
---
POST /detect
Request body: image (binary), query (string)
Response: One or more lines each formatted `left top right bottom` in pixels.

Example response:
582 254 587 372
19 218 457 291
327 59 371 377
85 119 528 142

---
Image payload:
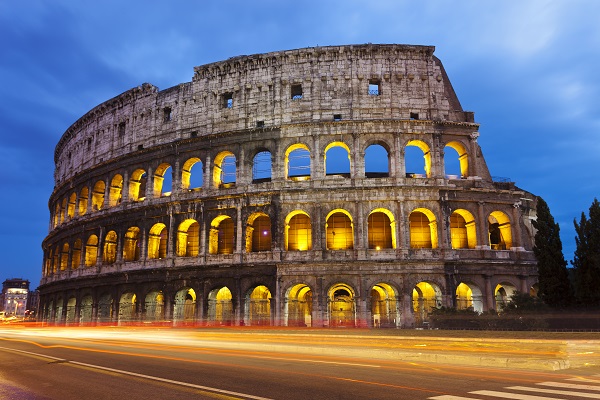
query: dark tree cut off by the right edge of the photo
571 199 600 306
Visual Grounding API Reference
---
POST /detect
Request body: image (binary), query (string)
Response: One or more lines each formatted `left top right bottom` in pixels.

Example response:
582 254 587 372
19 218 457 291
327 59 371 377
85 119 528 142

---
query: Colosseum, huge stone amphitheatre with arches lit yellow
39 44 537 327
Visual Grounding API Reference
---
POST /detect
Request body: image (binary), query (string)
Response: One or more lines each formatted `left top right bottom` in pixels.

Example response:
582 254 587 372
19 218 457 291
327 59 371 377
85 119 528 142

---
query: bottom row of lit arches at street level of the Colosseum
44 281 516 328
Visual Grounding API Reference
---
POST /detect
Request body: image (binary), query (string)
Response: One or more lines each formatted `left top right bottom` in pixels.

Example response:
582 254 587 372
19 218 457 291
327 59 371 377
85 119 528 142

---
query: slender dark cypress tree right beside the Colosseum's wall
533 197 572 307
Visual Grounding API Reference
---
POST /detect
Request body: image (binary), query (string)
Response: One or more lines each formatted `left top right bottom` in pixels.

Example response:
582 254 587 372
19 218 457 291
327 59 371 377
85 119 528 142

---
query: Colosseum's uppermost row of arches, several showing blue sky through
51 140 469 227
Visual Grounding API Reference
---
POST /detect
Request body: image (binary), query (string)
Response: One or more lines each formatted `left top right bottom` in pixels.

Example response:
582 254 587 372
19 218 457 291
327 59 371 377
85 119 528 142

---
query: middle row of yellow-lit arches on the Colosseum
44 207 512 276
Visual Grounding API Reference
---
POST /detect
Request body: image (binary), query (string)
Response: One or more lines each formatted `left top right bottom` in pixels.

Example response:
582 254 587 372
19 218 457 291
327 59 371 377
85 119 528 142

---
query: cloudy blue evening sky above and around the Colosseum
0 0 600 289
